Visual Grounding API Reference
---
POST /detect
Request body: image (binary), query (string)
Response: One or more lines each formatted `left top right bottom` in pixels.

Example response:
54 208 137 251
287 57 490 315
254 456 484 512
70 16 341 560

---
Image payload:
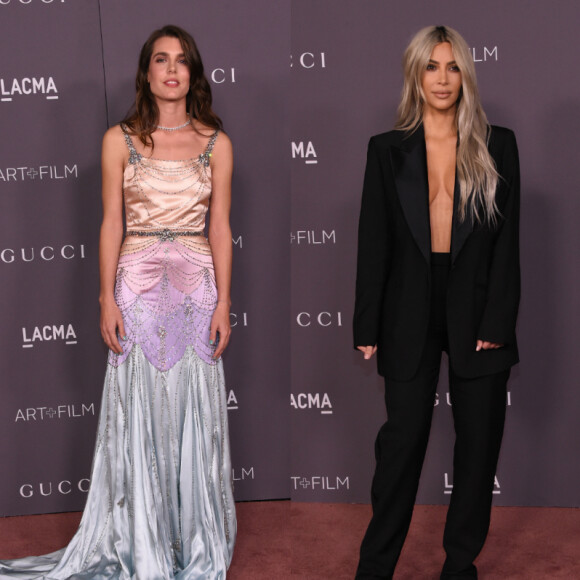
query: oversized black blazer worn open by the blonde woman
353 125 520 381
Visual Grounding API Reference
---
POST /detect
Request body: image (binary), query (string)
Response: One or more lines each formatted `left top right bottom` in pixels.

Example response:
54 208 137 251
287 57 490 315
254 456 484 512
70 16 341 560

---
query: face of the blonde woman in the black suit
421 42 461 112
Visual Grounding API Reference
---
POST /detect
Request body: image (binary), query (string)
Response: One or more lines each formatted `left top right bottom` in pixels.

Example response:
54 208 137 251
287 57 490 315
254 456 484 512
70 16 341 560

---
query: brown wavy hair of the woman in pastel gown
122 25 223 147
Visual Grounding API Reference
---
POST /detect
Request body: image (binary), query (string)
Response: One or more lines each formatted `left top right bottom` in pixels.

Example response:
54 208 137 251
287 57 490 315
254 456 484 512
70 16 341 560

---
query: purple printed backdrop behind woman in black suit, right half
290 0 580 506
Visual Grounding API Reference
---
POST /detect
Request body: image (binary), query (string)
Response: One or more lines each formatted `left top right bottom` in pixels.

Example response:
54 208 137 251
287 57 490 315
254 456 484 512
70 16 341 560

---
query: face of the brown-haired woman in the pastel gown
147 36 190 101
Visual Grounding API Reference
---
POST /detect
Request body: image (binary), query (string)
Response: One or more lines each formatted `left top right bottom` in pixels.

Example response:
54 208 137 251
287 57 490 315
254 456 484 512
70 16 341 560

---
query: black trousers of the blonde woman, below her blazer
356 254 509 580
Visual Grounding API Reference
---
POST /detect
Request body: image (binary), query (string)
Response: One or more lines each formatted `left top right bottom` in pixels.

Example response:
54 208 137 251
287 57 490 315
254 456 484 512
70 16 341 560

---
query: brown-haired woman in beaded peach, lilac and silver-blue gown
0 26 236 580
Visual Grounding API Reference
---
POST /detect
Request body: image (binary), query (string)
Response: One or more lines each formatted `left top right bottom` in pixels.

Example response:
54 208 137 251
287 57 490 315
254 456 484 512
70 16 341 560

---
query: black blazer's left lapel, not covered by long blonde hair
391 125 431 263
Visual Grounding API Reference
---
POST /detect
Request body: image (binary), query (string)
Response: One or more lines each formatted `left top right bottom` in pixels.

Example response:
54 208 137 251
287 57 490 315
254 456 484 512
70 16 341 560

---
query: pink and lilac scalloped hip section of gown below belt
109 238 217 371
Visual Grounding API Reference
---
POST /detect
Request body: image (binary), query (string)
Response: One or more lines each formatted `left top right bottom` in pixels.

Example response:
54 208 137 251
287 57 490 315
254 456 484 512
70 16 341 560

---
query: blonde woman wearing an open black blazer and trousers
354 26 520 580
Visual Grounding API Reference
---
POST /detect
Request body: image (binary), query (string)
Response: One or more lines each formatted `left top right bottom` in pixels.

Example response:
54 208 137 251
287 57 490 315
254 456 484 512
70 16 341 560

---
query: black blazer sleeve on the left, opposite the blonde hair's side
353 138 388 348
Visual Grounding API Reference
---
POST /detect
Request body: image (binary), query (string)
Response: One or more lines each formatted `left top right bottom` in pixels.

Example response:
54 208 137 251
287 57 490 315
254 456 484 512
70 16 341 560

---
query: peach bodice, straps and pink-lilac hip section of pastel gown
109 126 218 371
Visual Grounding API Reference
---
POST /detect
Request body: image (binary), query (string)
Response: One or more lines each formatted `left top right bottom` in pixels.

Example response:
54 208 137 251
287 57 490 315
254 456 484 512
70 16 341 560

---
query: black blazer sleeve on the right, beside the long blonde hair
477 131 520 344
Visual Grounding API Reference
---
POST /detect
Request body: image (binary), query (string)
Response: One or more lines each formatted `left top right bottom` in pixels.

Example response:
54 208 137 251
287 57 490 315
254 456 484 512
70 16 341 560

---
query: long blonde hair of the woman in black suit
395 26 499 224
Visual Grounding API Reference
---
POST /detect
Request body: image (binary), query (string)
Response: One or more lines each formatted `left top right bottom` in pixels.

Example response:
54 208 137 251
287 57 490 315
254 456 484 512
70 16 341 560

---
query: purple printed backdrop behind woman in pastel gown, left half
0 0 290 515
